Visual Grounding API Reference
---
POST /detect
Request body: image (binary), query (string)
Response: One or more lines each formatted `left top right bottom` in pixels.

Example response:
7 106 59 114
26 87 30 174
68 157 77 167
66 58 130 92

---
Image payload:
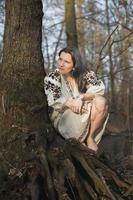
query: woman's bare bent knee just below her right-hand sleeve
93 95 108 112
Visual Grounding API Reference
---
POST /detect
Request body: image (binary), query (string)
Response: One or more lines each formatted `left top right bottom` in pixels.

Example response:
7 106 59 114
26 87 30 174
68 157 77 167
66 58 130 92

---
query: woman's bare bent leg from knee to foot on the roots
86 95 108 151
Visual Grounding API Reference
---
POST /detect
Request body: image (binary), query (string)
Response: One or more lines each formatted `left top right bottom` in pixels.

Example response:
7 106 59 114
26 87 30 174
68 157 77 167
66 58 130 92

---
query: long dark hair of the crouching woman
59 47 88 92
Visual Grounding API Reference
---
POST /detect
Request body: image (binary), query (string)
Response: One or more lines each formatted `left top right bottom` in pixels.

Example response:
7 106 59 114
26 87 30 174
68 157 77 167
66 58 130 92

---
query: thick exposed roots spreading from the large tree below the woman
26 129 133 200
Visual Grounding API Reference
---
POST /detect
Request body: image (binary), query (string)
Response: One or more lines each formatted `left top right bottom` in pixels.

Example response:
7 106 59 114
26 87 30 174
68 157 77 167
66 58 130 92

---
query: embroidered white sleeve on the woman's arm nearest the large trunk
44 70 66 110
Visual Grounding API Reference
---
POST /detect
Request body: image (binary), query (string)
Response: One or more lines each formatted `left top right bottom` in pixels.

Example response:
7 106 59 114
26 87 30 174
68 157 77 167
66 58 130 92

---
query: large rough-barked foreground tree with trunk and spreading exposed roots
0 0 132 200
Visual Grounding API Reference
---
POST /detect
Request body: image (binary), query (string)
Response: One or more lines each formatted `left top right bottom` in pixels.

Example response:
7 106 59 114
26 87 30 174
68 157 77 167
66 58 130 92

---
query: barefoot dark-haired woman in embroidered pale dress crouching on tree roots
44 47 108 152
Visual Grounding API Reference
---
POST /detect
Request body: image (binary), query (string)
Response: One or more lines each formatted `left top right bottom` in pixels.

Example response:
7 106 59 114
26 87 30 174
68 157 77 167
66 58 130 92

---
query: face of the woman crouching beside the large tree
58 52 74 76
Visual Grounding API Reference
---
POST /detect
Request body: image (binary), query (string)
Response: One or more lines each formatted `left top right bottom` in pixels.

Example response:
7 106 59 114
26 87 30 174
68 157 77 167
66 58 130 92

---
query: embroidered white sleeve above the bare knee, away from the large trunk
85 71 105 95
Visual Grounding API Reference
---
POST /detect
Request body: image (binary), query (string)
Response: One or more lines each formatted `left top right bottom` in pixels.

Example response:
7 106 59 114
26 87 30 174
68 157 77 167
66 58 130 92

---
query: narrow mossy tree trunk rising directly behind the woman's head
65 0 78 47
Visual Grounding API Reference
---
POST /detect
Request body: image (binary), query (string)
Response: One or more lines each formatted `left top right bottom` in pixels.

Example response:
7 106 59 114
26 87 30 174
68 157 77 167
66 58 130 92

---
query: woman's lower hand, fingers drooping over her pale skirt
65 98 83 113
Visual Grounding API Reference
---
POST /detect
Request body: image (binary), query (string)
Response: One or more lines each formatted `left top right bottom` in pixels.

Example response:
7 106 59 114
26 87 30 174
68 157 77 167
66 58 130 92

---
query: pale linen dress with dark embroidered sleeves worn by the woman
44 69 108 144
